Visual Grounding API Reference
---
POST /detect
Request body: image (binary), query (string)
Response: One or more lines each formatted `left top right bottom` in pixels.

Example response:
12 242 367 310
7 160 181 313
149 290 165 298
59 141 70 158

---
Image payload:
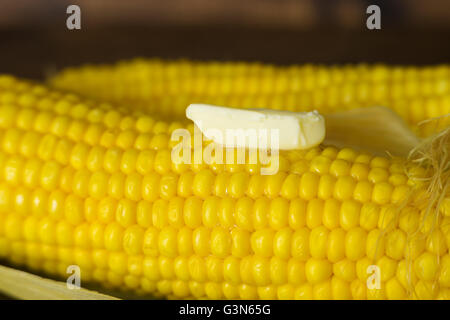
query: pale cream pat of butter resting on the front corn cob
186 104 325 150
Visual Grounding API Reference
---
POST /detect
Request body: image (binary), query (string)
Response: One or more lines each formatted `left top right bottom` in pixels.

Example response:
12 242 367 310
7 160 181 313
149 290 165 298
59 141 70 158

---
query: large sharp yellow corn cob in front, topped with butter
0 76 450 299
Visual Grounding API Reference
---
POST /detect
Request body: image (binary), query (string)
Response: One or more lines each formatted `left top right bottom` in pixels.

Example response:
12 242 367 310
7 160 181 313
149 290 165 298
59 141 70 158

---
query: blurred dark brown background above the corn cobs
0 0 450 78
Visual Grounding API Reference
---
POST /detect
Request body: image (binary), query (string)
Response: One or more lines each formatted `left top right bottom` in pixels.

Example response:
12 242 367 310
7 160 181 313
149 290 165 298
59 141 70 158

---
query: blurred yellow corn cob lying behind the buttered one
49 59 450 136
